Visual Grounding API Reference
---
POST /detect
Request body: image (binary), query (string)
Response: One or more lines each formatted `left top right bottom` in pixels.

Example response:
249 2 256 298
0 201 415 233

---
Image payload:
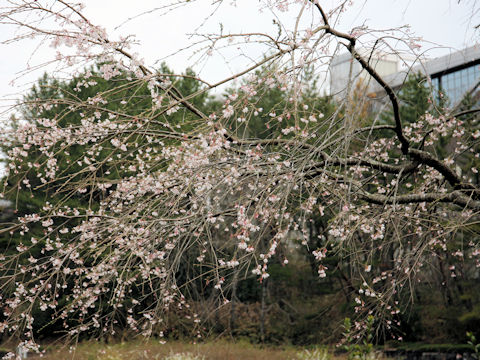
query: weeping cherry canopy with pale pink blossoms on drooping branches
0 0 480 354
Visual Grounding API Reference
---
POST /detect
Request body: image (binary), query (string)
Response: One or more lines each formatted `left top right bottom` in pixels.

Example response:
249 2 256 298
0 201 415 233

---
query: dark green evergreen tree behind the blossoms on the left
0 64 208 334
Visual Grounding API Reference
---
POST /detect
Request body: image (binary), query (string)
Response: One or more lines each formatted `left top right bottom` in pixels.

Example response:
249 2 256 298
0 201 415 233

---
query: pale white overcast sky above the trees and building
0 0 480 114
